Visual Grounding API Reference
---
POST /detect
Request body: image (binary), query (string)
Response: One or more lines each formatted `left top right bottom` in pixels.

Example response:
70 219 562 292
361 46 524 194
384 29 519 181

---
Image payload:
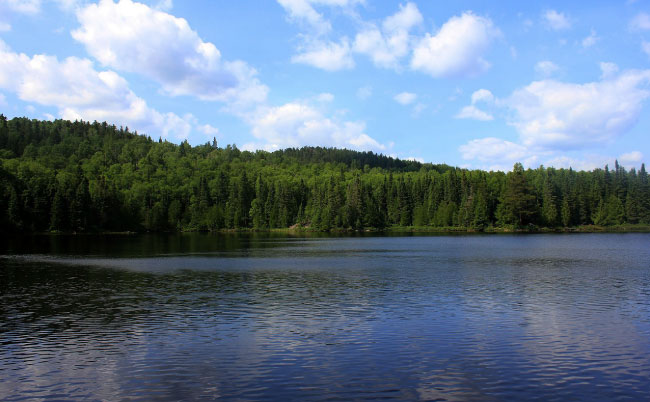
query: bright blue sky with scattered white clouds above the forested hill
0 0 650 170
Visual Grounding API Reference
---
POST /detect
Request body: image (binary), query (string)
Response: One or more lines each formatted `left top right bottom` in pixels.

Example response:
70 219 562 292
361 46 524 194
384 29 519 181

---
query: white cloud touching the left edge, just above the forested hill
0 41 193 138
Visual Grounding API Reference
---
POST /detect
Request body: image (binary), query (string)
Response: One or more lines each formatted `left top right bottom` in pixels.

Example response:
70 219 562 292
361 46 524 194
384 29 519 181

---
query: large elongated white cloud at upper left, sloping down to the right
72 0 268 104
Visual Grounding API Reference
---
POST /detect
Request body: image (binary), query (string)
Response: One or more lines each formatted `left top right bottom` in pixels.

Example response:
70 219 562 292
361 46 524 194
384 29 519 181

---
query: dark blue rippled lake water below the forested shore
0 234 650 401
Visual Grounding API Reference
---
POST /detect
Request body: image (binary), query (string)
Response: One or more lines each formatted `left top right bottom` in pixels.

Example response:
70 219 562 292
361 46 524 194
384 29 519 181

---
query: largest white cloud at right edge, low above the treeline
459 67 650 169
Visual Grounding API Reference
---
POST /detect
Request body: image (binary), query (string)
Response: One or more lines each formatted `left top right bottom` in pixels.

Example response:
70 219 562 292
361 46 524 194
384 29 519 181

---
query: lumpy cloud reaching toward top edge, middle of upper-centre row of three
354 3 422 68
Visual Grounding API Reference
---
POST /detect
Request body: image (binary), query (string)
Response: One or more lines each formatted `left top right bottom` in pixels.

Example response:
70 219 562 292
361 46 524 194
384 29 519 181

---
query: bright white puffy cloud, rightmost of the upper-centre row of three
411 12 500 77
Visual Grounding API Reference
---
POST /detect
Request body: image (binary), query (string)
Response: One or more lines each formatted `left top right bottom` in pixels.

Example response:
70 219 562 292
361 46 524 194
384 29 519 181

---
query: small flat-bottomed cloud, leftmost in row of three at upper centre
291 38 354 71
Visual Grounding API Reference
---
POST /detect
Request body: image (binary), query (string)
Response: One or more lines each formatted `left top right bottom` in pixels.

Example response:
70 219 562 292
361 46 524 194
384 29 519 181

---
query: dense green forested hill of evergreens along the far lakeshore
0 115 650 232
